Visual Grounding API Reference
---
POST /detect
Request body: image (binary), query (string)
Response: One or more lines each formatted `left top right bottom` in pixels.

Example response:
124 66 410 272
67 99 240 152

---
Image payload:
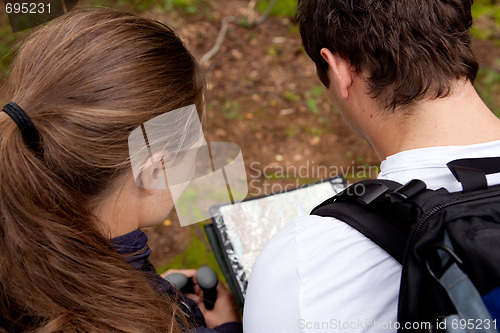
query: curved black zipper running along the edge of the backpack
398 191 500 324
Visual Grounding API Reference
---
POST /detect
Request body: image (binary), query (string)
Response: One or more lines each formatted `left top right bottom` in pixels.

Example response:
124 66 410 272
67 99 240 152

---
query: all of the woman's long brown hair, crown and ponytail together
0 9 204 332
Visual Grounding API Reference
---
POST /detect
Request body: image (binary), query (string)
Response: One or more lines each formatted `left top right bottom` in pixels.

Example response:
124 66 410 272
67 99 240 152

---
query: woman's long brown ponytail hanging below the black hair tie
0 110 186 332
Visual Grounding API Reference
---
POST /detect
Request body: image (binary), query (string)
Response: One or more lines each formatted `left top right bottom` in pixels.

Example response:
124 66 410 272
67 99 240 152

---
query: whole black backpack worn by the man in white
311 157 500 333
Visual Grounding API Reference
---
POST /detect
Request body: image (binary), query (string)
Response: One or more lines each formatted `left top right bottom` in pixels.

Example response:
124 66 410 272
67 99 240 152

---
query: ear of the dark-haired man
320 48 353 99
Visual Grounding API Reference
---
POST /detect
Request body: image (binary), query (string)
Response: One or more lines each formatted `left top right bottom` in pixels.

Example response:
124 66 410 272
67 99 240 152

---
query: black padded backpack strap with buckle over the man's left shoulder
311 179 412 263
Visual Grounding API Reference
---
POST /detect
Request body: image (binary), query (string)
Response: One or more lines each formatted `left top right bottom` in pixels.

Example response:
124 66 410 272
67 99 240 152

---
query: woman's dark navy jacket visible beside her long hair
111 229 243 333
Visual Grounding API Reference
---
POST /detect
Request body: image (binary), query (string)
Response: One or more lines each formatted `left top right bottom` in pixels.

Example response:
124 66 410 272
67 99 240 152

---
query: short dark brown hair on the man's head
297 0 478 109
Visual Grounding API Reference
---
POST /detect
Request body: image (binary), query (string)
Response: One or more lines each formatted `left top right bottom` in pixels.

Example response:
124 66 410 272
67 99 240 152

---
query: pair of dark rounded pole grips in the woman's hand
165 266 219 310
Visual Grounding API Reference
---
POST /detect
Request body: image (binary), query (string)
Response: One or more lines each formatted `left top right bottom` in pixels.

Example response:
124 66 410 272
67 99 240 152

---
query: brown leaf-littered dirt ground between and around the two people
146 0 500 265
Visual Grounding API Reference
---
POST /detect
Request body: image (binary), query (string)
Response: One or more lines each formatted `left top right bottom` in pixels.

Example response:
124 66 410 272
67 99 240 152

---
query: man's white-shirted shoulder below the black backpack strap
245 216 401 332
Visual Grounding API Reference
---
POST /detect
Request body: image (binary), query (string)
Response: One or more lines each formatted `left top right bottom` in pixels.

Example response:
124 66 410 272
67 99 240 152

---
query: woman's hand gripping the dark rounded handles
162 269 241 328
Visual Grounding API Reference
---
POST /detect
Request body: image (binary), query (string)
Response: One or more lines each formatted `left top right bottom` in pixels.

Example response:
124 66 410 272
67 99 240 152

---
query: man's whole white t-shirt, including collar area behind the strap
243 141 500 333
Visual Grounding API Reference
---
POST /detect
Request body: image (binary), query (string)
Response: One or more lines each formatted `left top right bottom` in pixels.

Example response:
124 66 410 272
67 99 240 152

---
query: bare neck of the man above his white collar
368 82 500 160
